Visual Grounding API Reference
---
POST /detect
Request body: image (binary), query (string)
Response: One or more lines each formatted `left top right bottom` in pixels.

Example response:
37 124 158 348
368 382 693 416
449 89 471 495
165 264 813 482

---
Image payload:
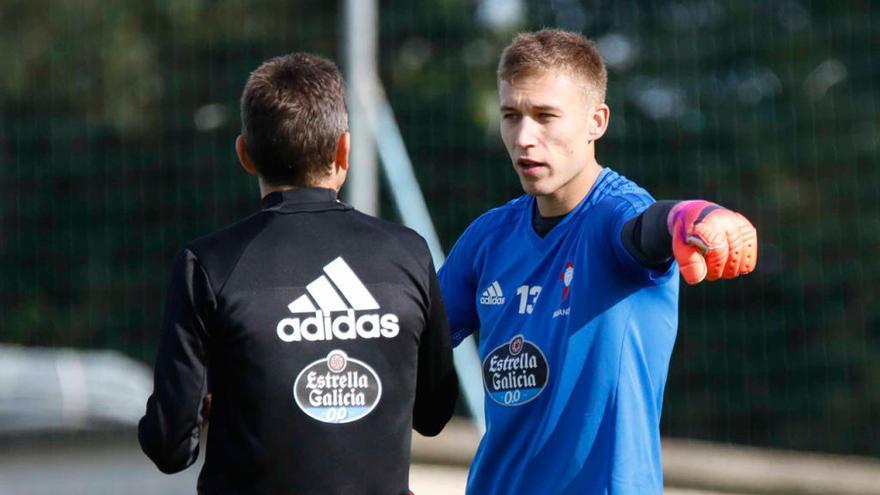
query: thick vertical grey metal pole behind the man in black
342 0 379 216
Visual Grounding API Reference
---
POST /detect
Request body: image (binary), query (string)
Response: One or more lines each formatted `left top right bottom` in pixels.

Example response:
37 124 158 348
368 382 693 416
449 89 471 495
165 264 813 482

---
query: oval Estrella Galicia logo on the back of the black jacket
293 349 382 423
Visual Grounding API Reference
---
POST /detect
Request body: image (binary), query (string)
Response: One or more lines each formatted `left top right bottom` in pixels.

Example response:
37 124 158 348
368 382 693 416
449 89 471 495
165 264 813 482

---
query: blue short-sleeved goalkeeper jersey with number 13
440 168 678 495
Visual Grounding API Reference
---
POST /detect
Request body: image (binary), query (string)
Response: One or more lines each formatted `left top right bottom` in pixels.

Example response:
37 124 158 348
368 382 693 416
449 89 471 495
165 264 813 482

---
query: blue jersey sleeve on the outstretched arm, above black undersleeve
605 193 677 285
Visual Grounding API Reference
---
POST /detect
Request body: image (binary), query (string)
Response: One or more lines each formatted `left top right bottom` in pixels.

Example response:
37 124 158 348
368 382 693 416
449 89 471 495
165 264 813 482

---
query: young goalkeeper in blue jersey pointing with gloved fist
440 30 757 495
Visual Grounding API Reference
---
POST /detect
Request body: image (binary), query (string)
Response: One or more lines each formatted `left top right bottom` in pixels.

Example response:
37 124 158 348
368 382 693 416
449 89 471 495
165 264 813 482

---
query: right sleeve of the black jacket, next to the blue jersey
413 264 458 436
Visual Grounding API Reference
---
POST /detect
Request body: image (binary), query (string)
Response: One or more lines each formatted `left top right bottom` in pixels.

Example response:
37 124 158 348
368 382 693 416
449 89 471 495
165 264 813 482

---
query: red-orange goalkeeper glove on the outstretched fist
666 200 758 285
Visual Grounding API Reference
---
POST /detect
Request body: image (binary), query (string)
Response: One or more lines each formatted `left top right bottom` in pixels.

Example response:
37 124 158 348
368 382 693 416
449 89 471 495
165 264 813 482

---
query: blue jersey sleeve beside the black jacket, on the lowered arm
438 224 480 347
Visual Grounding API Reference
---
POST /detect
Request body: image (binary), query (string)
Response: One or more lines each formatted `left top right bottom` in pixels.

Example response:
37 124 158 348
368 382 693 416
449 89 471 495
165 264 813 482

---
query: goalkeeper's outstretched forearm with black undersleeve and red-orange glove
621 200 758 285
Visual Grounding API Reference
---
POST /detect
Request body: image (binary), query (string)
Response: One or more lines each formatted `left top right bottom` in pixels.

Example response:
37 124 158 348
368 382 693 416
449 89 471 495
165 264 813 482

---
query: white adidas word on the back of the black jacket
276 309 400 342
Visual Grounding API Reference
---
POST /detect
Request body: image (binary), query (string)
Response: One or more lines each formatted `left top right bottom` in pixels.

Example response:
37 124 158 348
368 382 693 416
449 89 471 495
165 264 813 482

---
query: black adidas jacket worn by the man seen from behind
138 188 458 495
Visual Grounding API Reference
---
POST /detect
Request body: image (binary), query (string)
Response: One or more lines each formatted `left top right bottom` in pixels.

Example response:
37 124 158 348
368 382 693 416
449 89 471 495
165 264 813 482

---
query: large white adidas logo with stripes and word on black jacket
275 256 400 342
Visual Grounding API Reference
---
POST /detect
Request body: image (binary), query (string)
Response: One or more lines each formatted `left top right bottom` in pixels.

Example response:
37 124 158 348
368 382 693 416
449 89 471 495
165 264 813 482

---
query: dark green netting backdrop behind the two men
0 0 880 456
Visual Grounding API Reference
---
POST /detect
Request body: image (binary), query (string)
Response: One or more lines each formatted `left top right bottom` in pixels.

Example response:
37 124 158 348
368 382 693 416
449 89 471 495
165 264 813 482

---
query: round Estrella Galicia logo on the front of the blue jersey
483 335 549 406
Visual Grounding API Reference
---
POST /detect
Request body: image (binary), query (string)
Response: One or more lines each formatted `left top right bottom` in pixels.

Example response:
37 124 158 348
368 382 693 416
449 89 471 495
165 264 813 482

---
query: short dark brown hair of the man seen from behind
241 53 348 187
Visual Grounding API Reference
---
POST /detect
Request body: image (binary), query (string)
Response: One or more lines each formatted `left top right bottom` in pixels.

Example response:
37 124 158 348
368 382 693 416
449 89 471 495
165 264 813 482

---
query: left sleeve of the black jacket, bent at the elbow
138 249 215 474
